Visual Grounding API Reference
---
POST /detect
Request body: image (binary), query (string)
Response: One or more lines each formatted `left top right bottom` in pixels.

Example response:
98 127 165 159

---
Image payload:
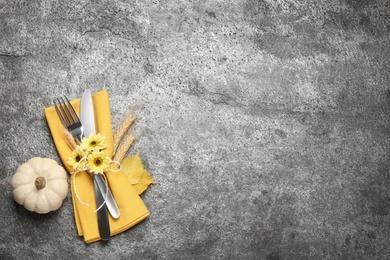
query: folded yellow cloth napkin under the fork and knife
44 90 149 243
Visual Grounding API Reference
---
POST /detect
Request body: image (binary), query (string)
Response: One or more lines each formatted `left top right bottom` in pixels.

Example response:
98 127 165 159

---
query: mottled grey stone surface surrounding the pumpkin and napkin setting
0 0 390 260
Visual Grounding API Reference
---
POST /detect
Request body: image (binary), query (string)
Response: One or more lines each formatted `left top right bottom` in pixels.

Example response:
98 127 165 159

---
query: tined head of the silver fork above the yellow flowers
54 96 84 143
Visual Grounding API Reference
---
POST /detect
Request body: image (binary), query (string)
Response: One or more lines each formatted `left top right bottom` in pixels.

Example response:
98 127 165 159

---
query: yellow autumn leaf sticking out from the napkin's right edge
122 152 155 194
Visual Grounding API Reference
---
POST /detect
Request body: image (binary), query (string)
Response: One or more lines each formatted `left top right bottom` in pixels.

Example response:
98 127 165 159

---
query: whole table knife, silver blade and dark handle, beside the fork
80 91 111 241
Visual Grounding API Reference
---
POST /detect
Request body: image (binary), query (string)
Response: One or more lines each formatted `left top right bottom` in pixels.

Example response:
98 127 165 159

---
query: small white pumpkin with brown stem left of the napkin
11 157 68 214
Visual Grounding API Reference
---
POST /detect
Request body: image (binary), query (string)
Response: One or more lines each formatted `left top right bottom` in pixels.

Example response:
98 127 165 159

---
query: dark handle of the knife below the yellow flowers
93 174 110 241
